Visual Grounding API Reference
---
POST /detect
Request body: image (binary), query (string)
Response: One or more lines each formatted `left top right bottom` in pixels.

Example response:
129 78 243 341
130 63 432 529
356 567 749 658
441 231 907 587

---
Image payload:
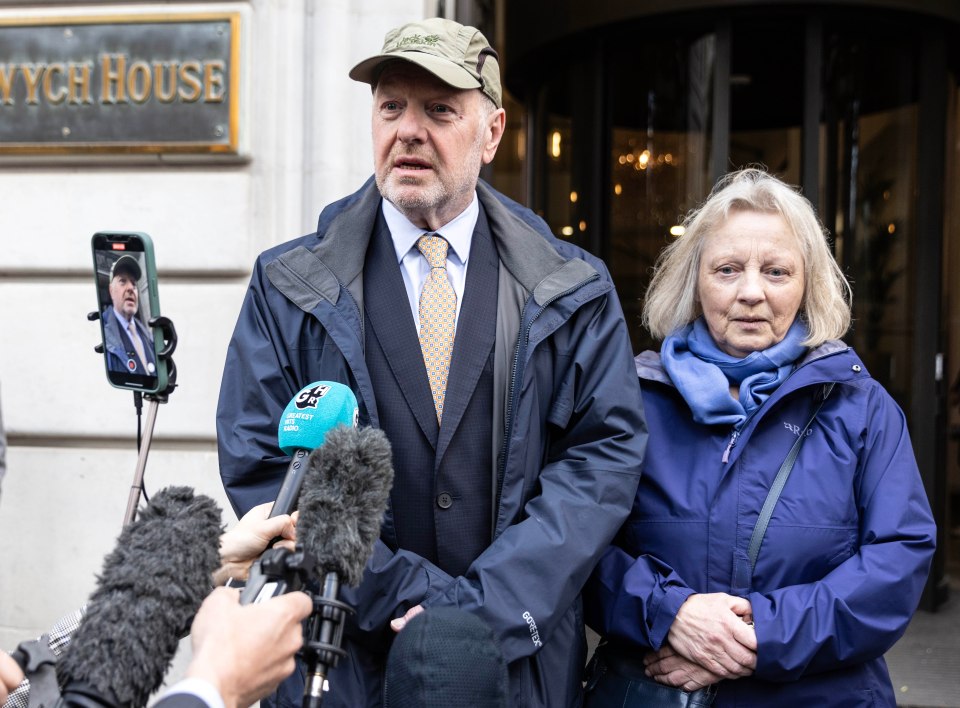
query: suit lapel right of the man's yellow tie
428 208 500 464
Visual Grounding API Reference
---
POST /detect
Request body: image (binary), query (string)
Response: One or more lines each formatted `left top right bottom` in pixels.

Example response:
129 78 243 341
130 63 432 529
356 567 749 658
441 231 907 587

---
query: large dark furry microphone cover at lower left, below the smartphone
57 487 223 708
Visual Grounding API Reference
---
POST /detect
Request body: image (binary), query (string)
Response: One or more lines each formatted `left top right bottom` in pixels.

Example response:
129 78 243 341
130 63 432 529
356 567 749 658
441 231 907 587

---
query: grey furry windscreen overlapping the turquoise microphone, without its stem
297 427 393 586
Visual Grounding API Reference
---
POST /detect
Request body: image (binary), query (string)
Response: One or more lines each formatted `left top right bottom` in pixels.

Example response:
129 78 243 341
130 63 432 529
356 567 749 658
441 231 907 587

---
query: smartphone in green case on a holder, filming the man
91 231 167 393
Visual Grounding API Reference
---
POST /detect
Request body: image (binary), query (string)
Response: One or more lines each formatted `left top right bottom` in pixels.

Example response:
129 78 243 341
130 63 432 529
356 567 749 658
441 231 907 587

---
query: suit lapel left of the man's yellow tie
363 215 438 448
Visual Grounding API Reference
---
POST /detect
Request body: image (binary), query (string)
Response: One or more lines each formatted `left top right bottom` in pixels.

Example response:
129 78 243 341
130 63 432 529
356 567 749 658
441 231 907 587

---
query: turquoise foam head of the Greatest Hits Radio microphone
277 381 359 455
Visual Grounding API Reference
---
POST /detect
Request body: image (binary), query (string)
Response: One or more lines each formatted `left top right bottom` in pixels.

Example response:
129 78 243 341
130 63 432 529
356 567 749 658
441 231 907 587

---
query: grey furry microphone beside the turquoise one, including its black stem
297 428 393 708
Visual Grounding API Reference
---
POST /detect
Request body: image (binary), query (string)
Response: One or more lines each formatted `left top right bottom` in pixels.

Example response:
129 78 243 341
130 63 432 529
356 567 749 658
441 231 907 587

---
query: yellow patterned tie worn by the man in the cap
417 234 457 423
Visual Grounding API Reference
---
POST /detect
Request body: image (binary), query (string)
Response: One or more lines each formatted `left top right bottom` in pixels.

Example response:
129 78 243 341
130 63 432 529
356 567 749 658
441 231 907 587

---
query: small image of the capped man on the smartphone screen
101 254 156 376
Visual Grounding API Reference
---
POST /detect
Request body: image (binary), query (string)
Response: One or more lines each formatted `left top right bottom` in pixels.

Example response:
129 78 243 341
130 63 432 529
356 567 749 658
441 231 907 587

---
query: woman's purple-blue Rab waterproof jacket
584 341 935 708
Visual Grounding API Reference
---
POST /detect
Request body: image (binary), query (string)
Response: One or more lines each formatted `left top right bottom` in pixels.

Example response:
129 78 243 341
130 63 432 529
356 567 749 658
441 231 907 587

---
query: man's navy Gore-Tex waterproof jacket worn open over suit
217 180 646 708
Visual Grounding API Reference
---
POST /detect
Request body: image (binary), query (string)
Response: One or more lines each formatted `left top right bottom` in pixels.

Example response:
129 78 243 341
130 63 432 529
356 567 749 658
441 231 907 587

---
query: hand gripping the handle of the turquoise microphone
213 502 297 585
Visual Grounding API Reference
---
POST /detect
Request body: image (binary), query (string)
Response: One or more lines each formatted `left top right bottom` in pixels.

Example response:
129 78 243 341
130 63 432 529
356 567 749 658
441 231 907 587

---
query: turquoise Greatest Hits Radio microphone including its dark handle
270 381 359 519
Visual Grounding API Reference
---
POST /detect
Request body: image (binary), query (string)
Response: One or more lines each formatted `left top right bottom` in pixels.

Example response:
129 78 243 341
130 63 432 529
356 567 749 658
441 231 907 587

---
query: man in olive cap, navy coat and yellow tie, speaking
217 19 646 708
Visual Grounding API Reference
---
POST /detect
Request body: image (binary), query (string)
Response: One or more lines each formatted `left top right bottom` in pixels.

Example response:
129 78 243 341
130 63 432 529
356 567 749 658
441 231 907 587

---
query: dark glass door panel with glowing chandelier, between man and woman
606 34 716 351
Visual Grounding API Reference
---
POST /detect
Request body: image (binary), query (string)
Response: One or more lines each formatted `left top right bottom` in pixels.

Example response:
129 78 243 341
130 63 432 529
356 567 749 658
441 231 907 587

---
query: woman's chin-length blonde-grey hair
643 167 853 347
